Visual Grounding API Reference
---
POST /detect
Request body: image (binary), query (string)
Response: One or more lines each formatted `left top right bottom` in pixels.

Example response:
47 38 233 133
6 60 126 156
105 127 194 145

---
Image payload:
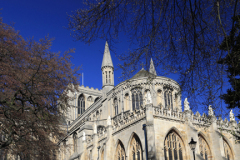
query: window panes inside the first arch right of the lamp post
198 135 211 160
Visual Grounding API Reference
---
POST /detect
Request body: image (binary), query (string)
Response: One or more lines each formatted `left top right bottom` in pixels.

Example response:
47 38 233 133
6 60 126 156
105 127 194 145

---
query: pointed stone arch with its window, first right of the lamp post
197 132 212 160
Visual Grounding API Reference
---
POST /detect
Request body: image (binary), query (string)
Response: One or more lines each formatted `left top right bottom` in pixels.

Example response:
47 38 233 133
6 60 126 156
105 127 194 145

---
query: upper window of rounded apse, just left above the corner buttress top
132 88 143 110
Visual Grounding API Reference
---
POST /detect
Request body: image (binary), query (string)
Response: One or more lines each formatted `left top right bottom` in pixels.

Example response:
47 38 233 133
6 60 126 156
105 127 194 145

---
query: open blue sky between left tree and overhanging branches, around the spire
0 0 131 89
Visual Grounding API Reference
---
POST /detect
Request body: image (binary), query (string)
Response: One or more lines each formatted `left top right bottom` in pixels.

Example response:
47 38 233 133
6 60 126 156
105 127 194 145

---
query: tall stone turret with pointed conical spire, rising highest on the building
101 42 114 94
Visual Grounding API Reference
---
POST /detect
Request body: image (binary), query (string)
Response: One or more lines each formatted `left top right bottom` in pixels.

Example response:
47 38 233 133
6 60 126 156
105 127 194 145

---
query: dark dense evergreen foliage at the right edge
219 15 240 117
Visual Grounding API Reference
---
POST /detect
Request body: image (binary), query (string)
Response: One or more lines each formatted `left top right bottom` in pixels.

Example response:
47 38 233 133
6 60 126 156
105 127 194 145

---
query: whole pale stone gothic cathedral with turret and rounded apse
57 42 240 160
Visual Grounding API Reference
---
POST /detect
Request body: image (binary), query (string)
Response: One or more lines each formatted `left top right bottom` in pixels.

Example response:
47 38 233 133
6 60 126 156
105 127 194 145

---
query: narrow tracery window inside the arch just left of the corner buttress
129 135 143 160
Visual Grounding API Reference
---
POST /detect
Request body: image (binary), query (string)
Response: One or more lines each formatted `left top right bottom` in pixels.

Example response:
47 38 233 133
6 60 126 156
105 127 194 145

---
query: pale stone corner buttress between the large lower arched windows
146 103 156 160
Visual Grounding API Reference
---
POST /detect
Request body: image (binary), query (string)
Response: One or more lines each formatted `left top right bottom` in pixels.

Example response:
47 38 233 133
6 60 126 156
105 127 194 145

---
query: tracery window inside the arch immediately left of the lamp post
164 132 183 160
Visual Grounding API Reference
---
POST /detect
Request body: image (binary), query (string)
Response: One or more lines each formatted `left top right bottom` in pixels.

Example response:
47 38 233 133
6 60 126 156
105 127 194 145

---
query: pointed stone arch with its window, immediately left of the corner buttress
127 132 143 160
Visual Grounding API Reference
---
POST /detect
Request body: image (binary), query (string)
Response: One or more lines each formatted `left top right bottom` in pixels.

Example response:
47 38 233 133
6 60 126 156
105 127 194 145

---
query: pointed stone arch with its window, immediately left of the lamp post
163 127 187 160
